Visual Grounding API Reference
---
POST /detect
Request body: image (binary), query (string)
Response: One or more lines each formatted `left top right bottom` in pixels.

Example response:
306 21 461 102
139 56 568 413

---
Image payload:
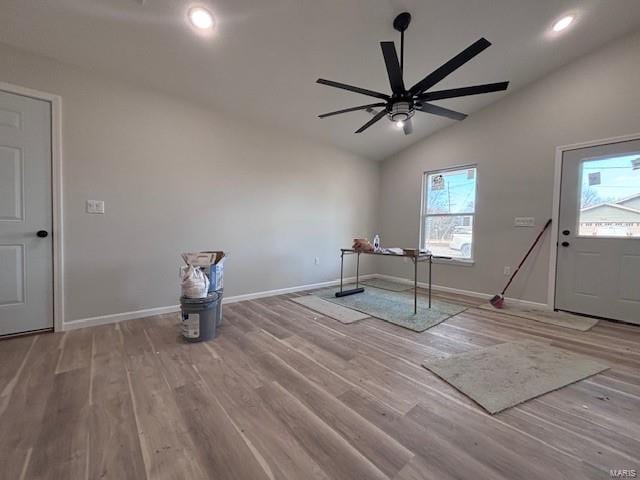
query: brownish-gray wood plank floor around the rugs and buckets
0 294 640 480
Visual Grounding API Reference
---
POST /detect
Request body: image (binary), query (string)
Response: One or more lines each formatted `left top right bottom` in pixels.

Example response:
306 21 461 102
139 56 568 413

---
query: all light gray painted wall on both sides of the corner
0 29 640 321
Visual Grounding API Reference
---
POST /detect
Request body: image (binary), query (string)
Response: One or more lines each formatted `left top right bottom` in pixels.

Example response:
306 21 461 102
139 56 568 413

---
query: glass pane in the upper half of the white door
578 152 640 237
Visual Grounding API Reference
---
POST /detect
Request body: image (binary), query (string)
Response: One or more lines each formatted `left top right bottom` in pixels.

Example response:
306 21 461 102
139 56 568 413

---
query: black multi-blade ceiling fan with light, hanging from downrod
317 12 509 135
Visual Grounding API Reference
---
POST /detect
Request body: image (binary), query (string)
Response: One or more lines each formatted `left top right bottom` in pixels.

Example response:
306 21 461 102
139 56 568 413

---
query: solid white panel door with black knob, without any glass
0 91 53 335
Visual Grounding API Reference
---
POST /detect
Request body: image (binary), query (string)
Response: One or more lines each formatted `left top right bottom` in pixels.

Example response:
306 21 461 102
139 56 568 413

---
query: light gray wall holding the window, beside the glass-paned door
380 30 640 303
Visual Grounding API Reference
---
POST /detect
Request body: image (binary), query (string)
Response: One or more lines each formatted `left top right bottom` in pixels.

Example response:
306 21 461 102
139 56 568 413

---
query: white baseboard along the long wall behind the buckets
62 274 376 331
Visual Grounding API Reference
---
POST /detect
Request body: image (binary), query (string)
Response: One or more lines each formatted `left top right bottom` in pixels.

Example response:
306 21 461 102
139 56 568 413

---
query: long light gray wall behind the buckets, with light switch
0 44 379 321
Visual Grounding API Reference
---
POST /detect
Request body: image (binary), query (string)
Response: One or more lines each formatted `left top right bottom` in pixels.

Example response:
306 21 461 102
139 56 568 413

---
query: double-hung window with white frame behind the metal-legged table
420 166 477 261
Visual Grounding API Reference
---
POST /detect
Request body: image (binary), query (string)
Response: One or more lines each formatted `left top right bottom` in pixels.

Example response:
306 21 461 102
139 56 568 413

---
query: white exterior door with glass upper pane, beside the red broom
555 140 640 324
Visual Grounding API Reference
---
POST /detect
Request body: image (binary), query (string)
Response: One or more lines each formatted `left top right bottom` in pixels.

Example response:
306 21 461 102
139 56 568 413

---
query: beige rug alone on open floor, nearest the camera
422 341 609 414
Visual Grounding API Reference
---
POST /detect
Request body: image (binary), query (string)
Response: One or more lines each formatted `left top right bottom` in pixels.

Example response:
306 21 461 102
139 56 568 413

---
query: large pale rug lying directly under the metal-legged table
313 285 467 332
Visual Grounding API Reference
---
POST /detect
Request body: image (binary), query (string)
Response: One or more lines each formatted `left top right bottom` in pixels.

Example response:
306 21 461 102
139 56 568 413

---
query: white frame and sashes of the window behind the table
419 163 479 266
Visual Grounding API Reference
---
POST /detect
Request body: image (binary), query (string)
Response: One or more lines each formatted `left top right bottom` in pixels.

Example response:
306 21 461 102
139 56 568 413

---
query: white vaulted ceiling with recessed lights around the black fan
0 0 640 159
